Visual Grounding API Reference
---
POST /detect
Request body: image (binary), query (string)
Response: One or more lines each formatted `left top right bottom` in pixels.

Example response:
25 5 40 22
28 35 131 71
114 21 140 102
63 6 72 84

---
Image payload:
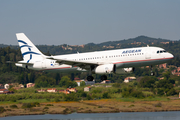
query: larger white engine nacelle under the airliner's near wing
94 64 114 74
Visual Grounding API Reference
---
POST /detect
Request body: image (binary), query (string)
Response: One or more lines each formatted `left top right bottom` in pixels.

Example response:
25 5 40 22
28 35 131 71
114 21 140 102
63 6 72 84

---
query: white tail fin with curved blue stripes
16 33 45 63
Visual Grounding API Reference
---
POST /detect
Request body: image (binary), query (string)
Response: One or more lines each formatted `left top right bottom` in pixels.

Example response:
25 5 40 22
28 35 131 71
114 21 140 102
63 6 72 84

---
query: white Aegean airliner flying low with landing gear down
15 33 174 81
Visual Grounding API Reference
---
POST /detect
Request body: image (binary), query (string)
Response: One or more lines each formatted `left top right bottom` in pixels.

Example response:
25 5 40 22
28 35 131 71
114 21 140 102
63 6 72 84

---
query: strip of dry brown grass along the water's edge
0 97 180 117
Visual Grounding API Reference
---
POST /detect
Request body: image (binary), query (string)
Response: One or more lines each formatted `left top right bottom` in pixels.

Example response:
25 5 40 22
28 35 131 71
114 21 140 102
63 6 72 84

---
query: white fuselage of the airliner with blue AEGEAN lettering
16 47 174 72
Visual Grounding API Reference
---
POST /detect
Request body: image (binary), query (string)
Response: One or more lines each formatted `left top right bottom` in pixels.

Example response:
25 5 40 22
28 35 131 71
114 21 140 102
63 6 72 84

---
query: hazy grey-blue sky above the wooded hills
0 0 180 45
